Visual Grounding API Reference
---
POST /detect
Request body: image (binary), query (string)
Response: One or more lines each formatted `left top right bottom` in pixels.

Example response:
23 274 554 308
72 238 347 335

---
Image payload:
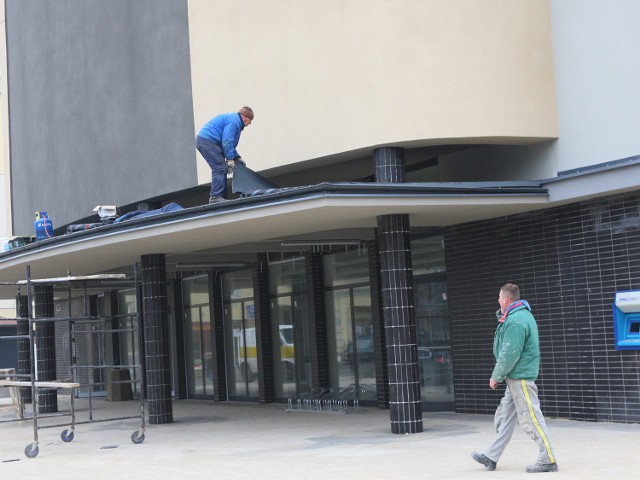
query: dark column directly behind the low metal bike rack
305 253 330 388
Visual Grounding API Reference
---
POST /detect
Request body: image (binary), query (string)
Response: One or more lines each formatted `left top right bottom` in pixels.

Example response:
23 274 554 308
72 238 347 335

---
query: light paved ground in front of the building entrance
0 399 640 480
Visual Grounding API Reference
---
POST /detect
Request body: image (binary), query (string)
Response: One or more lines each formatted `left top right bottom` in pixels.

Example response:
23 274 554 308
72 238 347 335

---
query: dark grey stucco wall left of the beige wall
6 0 197 235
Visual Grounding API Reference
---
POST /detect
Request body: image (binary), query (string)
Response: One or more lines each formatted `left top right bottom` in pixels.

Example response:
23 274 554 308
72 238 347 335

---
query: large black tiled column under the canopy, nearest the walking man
378 214 422 433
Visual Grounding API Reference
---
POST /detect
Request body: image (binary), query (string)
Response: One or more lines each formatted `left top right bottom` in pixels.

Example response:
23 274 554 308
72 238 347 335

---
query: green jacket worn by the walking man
491 301 540 382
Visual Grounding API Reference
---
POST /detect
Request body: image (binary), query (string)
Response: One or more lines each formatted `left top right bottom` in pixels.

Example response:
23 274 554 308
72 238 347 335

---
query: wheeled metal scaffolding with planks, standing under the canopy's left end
0 265 145 458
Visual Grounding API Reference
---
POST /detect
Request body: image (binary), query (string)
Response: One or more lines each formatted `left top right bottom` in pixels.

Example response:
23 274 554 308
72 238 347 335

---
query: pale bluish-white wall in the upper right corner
549 0 640 172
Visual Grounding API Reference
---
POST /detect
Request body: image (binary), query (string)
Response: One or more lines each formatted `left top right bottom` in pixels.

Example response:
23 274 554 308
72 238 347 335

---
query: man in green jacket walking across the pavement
471 283 558 473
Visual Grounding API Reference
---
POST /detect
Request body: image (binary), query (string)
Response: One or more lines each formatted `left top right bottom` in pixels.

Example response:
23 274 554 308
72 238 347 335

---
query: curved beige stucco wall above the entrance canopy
189 0 557 183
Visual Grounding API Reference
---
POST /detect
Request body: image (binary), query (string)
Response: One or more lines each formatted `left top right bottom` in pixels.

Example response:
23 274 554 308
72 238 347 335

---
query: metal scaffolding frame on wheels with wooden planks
0 264 145 458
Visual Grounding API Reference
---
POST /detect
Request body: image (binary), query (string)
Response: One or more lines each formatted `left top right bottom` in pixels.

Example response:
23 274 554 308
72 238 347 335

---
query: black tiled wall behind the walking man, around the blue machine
445 192 640 422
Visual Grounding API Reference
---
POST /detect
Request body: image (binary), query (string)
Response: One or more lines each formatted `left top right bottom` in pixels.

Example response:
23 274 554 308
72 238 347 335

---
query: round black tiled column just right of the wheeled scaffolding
142 254 173 424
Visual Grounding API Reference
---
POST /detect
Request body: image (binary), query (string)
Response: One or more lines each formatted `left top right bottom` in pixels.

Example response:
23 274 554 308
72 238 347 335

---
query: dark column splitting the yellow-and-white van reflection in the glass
253 255 276 403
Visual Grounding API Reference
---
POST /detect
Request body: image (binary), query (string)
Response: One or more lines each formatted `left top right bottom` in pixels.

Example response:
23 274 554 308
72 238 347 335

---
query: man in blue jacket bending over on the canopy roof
196 107 253 203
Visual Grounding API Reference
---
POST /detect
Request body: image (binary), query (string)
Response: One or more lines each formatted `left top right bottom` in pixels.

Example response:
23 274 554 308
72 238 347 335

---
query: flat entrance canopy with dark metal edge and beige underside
0 182 548 298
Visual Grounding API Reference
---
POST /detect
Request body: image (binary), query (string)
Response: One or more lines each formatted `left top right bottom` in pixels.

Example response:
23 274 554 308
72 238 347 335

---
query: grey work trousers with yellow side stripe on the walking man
482 378 556 464
